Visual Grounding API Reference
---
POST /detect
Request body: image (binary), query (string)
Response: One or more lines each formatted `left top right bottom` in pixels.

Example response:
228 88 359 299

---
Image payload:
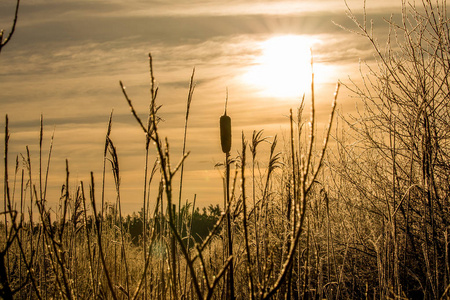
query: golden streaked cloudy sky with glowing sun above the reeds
0 0 401 213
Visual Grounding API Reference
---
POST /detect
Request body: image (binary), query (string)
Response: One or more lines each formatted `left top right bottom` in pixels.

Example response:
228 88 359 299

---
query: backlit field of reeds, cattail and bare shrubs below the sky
0 1 450 299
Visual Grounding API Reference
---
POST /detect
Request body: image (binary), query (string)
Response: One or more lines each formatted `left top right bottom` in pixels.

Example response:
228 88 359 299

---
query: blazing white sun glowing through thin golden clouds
244 35 317 98
